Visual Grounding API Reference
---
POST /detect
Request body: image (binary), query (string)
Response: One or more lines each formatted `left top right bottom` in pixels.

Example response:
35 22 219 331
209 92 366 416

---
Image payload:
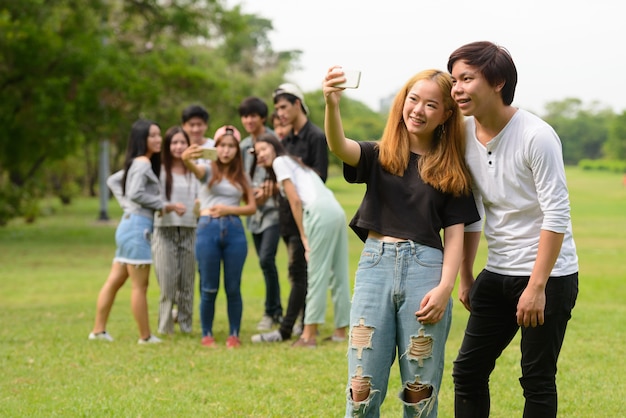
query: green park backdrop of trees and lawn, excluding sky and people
0 0 626 417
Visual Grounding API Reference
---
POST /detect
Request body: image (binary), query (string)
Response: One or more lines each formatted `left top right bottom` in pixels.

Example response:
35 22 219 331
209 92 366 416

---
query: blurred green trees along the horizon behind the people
0 0 626 225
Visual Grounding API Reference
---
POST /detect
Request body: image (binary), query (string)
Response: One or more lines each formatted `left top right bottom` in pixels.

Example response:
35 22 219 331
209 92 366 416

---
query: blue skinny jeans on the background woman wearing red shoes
196 215 248 337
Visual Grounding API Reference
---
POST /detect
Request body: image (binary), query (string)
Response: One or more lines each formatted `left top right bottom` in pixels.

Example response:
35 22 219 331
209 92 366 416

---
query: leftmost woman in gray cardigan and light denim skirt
89 120 173 344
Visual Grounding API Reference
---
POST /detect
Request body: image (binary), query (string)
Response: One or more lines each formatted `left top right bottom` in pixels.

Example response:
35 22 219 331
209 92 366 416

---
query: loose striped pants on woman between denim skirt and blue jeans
152 226 196 334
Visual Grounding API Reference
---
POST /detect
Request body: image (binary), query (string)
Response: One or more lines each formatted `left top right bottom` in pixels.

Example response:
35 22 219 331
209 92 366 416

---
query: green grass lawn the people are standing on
0 169 626 418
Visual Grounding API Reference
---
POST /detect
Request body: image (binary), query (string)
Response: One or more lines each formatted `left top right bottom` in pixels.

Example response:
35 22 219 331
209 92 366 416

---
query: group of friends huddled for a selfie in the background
89 84 350 348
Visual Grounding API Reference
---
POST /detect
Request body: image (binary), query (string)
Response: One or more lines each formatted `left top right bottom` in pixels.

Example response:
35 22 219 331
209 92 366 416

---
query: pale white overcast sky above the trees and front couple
227 0 626 114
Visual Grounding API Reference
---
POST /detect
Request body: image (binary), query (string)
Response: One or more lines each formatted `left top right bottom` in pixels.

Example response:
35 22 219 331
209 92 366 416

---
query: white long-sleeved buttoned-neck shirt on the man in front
465 109 578 276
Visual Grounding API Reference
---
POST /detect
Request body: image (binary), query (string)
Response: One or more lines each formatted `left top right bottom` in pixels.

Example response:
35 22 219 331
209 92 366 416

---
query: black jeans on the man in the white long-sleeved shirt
452 270 578 418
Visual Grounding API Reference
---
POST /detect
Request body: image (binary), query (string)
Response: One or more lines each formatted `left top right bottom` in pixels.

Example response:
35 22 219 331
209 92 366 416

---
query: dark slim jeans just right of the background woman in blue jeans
252 224 283 321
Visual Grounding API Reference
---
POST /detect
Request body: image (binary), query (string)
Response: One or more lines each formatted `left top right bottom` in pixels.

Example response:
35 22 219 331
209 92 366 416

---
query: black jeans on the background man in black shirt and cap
280 235 307 340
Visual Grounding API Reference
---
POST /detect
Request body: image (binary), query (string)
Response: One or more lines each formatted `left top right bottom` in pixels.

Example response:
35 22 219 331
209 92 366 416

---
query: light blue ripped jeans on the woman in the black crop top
346 238 452 418
